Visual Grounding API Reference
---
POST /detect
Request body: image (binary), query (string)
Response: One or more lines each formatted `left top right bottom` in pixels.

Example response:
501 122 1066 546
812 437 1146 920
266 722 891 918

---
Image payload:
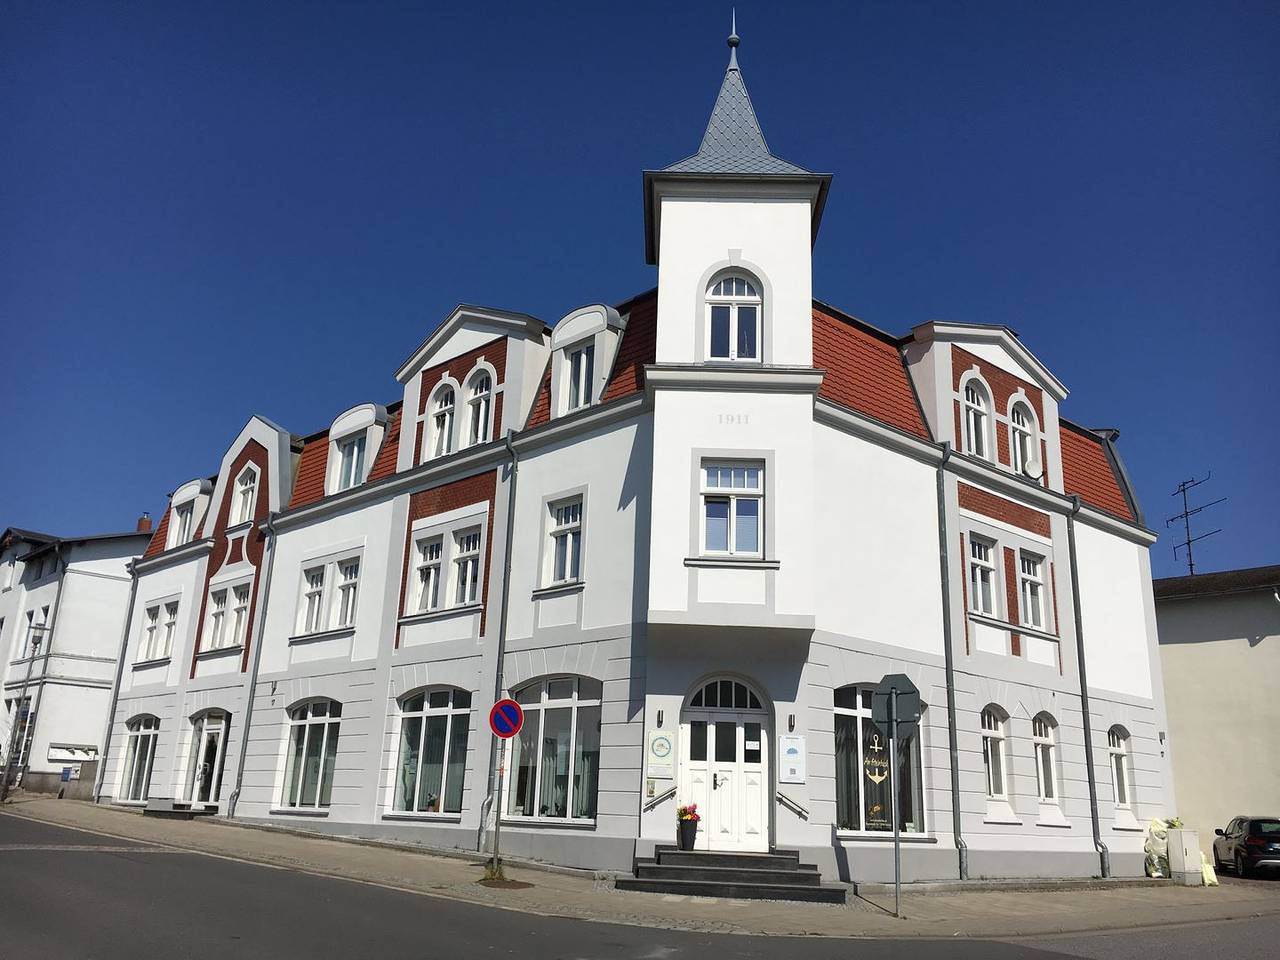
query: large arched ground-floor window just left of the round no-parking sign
394 689 471 813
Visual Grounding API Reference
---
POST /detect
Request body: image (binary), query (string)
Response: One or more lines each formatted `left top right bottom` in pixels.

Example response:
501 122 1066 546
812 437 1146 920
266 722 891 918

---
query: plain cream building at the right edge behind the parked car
1155 566 1280 854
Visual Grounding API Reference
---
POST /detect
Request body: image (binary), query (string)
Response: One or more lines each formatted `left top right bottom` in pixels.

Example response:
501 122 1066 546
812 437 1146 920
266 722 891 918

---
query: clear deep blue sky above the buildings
0 0 1280 576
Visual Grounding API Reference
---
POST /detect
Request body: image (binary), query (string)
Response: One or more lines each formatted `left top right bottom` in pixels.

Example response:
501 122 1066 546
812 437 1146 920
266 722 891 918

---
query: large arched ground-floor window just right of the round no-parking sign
507 677 602 820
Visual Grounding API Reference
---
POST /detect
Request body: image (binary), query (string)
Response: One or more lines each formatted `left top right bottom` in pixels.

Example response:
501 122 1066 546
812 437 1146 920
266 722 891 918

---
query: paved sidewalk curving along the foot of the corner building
0 799 1280 938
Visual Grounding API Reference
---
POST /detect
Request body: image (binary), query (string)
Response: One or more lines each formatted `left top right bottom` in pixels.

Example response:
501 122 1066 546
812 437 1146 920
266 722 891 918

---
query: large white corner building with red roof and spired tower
92 33 1172 879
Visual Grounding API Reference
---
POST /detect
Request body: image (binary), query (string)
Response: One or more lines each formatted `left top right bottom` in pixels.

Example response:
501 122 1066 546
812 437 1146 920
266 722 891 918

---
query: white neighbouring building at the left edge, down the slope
0 527 151 792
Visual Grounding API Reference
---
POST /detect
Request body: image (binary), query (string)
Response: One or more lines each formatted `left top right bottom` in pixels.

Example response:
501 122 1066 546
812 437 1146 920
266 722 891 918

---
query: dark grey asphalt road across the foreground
0 815 1280 960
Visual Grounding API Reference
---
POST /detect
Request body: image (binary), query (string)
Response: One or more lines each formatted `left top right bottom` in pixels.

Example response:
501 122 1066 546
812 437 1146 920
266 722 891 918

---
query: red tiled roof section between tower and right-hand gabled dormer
813 307 929 439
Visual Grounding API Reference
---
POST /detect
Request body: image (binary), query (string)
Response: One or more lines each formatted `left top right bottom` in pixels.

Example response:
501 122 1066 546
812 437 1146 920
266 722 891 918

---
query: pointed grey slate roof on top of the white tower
644 18 831 264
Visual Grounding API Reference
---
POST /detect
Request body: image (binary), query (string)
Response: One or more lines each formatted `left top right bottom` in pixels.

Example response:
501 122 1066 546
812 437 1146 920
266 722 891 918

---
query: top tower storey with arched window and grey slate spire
644 23 831 366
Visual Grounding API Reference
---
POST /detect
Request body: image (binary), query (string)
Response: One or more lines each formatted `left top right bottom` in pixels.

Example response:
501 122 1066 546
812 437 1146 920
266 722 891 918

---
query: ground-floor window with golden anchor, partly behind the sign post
835 686 924 833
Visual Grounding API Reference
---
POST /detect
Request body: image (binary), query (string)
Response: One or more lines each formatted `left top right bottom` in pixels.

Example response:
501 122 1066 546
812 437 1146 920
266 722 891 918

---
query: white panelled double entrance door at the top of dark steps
678 681 769 852
